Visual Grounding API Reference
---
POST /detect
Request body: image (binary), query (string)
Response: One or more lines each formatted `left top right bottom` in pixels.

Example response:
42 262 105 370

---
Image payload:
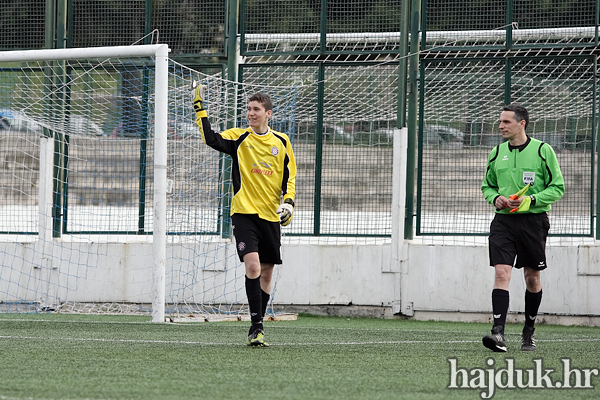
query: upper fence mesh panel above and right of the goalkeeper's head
241 0 401 55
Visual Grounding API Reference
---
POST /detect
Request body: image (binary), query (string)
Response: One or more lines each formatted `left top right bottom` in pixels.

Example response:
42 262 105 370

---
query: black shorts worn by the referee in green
489 213 550 271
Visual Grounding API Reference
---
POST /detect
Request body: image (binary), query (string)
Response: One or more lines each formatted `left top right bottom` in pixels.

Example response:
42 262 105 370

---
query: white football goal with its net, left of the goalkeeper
0 45 296 321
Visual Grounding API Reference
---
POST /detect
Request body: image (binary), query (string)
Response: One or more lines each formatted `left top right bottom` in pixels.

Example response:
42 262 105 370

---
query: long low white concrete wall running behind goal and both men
0 242 600 324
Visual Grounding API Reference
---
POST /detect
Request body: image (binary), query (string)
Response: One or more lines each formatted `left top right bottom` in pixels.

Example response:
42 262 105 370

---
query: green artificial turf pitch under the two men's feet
0 314 600 400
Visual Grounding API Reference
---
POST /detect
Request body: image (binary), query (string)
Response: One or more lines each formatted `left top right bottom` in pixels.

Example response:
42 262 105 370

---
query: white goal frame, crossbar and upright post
0 44 170 322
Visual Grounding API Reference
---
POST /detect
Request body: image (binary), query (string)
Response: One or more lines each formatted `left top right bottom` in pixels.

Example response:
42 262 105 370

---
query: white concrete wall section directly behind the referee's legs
407 245 600 316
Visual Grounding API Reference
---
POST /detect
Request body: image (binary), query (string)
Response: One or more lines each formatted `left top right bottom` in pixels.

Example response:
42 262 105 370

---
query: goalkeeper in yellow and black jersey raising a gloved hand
192 85 296 346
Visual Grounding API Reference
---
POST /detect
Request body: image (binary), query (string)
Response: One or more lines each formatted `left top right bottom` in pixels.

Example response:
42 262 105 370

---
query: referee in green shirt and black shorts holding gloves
481 104 565 352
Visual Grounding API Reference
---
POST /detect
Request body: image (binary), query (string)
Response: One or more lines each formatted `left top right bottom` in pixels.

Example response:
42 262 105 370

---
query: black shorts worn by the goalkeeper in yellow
231 214 281 264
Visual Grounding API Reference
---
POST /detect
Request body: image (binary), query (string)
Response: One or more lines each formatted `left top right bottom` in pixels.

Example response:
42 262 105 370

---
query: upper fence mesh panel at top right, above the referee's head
423 0 598 50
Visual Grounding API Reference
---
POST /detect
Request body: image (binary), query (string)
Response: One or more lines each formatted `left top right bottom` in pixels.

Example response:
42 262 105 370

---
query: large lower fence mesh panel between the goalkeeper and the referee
242 63 398 236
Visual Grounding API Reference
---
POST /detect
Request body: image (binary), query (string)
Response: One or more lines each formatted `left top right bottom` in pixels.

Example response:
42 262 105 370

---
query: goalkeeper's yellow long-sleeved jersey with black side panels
196 117 296 222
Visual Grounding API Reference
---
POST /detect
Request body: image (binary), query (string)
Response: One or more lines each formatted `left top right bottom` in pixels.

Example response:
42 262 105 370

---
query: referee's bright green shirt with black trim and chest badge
481 136 565 214
